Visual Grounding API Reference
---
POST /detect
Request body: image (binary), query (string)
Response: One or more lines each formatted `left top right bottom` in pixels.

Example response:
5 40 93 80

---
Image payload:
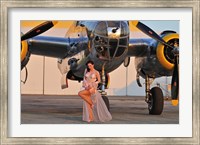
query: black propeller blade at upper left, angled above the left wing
21 21 57 41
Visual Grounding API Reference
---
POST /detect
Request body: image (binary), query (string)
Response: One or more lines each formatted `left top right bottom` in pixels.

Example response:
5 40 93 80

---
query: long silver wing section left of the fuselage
28 36 88 59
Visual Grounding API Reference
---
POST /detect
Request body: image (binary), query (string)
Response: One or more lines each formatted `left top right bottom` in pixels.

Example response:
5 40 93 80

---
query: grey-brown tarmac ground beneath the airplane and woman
21 95 179 124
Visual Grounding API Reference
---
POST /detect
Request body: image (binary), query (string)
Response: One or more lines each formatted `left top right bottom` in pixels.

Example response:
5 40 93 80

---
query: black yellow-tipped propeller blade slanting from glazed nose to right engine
130 20 174 49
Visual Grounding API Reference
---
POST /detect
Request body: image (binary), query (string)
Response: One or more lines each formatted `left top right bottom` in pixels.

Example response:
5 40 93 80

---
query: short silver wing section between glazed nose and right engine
127 38 152 57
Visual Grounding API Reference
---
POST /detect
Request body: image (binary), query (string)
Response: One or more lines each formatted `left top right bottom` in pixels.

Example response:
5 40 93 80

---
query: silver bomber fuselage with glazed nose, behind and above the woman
66 21 130 77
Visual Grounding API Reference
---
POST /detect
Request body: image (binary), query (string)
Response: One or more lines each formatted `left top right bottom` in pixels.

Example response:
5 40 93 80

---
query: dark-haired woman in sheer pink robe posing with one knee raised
78 60 112 122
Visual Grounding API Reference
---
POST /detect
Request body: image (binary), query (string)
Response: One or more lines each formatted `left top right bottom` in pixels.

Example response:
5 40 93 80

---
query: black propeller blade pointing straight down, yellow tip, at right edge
171 56 179 106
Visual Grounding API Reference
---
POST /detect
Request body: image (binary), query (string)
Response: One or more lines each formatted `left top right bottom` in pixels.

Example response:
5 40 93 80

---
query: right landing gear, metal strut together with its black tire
145 76 164 115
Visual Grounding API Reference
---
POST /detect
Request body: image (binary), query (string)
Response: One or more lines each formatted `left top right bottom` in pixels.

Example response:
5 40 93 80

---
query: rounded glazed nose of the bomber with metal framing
93 21 129 59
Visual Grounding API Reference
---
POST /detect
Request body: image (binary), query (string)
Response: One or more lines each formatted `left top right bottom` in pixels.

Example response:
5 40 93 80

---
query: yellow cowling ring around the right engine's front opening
156 33 179 70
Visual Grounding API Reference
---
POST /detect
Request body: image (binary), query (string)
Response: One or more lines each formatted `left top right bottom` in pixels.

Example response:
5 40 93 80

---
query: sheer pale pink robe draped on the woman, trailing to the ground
83 71 112 122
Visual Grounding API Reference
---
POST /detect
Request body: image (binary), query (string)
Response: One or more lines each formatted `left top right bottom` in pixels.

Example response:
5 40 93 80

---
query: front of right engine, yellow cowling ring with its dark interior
156 33 179 70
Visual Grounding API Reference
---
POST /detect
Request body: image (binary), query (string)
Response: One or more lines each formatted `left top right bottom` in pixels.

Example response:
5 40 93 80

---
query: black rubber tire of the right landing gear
148 87 164 115
